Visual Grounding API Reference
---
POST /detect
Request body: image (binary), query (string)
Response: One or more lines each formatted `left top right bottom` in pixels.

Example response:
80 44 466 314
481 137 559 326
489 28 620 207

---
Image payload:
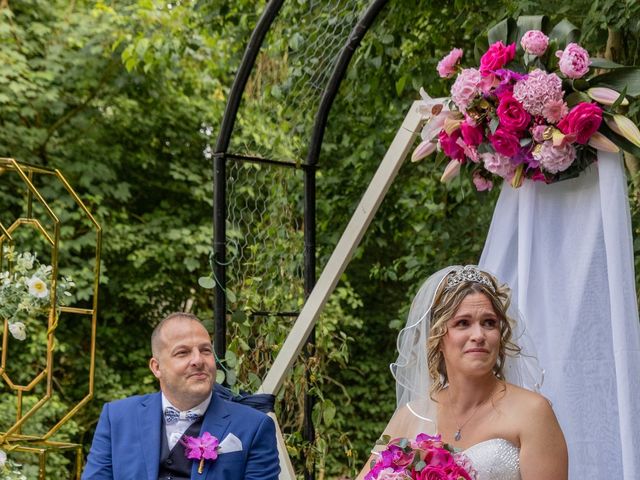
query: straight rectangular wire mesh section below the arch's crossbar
227 161 304 312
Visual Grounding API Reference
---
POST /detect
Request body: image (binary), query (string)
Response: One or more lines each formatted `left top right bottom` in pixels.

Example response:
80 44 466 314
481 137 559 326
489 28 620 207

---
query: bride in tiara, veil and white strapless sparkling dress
358 265 568 480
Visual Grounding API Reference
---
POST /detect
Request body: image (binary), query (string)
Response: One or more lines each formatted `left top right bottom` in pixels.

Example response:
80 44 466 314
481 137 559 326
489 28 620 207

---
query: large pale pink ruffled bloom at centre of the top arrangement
513 69 564 117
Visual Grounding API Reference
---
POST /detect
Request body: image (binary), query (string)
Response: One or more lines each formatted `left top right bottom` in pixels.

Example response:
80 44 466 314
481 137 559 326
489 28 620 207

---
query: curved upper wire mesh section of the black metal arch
229 0 368 163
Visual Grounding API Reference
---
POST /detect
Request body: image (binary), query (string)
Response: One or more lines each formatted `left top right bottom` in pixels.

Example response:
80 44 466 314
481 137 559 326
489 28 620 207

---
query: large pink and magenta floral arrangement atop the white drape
412 17 640 191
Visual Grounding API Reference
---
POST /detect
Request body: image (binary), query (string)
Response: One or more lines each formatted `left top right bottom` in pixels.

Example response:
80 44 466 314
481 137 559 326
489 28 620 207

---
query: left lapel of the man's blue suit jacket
136 392 162 480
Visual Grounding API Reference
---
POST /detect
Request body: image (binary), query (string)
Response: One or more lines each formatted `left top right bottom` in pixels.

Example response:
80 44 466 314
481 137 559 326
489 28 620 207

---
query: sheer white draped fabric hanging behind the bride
479 153 640 480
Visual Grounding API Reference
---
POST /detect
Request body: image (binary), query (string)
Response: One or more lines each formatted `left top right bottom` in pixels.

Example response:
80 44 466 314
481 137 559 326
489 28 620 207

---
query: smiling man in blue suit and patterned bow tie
82 313 280 480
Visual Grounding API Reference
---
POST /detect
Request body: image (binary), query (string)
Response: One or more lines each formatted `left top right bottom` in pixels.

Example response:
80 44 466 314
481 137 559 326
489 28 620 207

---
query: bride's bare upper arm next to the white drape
520 396 569 480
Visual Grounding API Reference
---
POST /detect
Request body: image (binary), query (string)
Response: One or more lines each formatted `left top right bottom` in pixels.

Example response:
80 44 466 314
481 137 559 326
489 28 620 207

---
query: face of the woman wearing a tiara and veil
440 293 500 378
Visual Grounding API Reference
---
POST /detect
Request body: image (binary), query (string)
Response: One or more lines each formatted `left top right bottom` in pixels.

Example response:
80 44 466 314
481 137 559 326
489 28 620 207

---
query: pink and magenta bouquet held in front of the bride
365 433 477 480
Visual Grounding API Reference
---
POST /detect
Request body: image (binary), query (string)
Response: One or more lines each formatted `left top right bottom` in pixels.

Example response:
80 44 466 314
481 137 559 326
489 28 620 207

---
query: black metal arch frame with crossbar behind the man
213 0 388 480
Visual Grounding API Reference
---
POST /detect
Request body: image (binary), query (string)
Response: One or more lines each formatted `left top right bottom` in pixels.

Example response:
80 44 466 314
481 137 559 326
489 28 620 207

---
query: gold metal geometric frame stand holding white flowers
0 158 102 478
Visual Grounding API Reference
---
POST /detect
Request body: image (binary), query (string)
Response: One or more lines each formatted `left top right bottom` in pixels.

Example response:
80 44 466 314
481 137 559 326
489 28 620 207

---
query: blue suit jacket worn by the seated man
82 392 280 480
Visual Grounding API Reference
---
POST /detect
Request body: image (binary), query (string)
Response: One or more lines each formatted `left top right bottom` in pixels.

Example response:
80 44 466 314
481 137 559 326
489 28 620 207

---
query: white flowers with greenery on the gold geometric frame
0 246 75 340
